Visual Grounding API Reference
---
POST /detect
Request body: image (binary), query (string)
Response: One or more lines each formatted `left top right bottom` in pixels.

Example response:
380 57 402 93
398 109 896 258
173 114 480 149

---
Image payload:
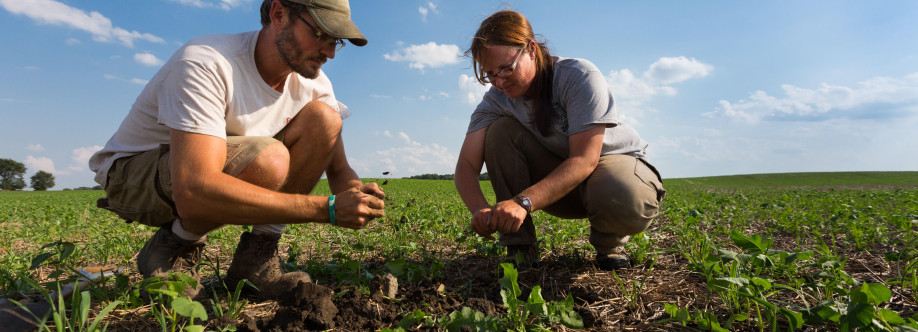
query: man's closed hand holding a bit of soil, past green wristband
335 188 386 229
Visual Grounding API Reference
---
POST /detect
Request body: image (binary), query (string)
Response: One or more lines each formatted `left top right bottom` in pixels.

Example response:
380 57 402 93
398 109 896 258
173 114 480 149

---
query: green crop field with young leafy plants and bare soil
0 172 918 331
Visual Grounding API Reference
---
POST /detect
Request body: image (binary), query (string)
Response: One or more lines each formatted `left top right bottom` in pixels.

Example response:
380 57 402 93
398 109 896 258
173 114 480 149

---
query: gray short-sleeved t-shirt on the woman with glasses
466 57 647 159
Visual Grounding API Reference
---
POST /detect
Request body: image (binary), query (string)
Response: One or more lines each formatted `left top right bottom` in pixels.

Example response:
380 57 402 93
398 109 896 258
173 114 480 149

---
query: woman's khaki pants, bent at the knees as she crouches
485 117 666 252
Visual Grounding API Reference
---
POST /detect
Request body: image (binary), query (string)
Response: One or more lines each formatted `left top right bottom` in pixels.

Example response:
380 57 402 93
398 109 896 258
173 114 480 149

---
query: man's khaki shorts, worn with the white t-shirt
96 136 284 227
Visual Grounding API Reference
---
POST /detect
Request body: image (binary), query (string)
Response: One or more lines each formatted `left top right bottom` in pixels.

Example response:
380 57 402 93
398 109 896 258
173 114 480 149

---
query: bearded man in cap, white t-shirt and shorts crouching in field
89 0 384 297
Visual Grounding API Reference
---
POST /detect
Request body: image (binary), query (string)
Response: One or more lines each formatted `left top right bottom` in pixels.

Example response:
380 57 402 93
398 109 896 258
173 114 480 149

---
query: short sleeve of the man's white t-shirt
157 60 227 139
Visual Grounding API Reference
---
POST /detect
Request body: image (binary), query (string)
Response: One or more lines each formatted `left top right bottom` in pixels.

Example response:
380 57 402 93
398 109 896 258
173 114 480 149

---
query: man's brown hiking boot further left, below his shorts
137 223 207 299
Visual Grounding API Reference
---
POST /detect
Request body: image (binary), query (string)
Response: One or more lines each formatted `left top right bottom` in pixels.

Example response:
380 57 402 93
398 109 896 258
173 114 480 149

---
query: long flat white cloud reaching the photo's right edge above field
703 73 918 124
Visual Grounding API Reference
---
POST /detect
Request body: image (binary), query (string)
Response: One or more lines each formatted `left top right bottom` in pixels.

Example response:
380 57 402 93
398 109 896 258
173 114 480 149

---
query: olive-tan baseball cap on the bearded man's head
289 0 367 46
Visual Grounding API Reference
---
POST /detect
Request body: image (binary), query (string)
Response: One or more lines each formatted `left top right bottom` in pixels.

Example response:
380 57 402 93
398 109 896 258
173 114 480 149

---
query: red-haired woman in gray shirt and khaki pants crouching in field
455 10 666 270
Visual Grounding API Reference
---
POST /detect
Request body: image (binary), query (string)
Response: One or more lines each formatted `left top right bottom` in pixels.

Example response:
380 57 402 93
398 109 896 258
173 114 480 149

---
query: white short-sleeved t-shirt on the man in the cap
89 31 350 187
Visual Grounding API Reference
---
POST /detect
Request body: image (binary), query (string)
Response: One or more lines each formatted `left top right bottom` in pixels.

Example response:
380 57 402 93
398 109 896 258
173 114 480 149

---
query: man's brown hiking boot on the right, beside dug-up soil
226 232 312 297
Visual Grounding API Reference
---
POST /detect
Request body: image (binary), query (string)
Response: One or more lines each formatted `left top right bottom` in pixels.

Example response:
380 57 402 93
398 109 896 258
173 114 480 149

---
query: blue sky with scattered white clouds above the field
0 0 918 189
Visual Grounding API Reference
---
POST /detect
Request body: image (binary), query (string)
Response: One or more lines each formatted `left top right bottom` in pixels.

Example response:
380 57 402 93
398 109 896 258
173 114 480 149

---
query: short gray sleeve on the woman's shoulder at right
558 60 618 135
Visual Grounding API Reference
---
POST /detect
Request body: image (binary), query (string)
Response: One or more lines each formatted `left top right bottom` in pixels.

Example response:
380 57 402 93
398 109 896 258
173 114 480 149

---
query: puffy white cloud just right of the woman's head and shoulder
606 56 714 118
